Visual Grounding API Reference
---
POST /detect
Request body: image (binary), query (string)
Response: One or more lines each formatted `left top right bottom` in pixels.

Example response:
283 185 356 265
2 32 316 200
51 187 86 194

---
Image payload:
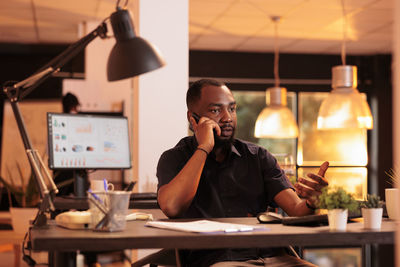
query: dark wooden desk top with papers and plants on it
31 218 396 251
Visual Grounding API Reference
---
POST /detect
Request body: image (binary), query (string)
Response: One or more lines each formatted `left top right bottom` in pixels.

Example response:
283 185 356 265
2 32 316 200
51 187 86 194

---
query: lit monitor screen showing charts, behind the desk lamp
47 113 131 169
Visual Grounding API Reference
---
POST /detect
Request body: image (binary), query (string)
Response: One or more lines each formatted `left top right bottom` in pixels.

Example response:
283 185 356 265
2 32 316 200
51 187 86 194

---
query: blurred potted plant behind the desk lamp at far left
0 163 40 233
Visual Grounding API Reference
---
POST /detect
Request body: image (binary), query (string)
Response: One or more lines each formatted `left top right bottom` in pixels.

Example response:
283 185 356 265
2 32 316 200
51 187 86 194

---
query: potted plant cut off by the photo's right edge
385 169 400 220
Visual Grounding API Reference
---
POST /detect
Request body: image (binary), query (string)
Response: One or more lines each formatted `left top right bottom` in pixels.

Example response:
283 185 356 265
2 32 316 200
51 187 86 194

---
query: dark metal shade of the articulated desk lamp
107 9 165 81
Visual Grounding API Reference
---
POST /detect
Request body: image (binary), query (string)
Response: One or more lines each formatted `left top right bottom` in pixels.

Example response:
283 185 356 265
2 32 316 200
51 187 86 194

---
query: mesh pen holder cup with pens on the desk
89 191 131 232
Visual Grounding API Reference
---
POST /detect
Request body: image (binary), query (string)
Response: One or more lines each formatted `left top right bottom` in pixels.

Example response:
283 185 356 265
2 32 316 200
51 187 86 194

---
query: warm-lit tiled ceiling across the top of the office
0 0 394 54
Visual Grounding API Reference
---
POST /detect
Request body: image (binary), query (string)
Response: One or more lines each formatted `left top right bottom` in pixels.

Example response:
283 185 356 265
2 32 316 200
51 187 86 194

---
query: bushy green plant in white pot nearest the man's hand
317 187 358 231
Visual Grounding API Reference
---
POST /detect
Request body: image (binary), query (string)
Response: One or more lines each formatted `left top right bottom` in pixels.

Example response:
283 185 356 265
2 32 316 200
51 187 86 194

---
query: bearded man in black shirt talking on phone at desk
157 79 329 266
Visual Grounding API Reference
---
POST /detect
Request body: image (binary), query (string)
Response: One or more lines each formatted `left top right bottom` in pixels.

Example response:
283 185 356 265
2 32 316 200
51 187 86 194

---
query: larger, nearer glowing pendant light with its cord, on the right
317 0 373 130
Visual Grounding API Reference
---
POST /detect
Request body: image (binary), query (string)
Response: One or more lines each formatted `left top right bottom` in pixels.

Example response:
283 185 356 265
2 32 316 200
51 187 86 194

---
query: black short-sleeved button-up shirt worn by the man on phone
157 136 292 218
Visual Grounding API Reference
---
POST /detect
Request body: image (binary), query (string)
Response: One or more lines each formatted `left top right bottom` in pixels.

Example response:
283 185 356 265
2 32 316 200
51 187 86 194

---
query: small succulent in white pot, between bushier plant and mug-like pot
360 194 383 229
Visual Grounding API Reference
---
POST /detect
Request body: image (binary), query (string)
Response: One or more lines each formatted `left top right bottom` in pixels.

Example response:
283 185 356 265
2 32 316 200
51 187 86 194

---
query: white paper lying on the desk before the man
146 220 268 233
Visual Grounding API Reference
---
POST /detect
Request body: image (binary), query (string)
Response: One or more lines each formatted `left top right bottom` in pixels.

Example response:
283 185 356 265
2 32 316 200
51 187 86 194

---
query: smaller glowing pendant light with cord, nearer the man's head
254 16 299 138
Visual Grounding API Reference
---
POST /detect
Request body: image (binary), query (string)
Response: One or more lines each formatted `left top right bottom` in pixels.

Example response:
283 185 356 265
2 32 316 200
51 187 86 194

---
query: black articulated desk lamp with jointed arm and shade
3 6 165 226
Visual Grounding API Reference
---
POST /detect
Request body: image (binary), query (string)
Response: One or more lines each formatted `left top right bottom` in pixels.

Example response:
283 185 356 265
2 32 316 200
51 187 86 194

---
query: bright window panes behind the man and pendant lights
233 91 368 199
